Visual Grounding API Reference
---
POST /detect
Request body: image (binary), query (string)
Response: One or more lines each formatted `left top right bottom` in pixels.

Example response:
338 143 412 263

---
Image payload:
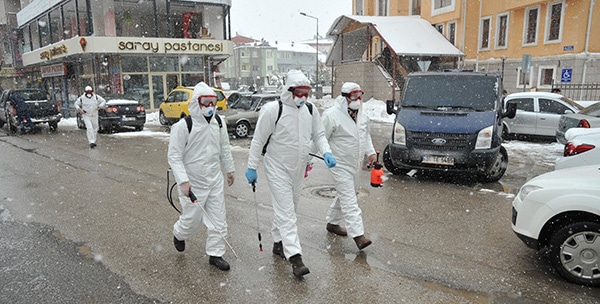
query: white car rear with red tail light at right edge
554 128 600 170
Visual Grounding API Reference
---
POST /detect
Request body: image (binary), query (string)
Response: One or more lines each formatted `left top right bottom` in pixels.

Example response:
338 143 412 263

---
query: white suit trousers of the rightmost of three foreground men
325 167 365 238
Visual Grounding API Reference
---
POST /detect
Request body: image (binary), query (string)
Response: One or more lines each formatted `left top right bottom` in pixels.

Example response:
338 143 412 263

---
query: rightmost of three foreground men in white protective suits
323 82 377 250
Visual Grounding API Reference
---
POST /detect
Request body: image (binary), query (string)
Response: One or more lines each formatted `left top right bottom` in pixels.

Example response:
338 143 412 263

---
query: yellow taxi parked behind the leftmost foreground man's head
158 86 227 125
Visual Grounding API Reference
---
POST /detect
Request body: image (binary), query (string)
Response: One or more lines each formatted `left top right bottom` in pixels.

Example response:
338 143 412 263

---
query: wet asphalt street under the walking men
0 124 600 303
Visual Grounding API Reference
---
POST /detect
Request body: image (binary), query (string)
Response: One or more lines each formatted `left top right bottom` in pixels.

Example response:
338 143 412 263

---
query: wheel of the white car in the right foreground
550 222 600 286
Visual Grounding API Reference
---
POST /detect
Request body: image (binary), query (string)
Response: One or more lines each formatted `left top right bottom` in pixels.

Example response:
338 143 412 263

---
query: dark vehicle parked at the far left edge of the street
0 89 62 132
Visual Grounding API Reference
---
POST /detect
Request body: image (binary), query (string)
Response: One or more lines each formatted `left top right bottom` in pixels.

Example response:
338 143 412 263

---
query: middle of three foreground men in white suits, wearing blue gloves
246 70 335 278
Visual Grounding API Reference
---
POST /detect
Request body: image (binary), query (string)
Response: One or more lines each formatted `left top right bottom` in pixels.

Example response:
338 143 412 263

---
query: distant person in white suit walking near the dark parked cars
75 86 106 149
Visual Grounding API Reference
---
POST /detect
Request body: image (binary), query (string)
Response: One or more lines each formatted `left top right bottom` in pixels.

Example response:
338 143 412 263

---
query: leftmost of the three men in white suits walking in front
167 82 235 271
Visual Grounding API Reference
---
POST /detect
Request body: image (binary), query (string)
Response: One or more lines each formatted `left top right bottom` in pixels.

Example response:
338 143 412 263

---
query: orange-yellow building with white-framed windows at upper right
353 0 600 100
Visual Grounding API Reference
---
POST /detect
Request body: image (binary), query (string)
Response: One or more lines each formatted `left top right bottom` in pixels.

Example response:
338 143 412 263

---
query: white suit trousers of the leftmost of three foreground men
173 181 227 257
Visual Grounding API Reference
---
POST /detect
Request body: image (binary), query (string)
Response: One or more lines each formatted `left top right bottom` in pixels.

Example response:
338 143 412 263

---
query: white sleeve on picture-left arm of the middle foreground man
248 102 278 169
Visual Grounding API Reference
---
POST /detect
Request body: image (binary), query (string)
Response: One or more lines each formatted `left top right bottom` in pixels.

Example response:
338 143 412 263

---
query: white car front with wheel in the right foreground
512 165 600 286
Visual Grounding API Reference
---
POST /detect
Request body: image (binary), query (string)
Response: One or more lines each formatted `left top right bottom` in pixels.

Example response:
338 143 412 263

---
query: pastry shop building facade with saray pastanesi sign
2 0 233 109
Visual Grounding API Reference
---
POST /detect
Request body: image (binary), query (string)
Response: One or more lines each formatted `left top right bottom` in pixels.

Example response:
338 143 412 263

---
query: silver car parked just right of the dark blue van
502 92 583 138
